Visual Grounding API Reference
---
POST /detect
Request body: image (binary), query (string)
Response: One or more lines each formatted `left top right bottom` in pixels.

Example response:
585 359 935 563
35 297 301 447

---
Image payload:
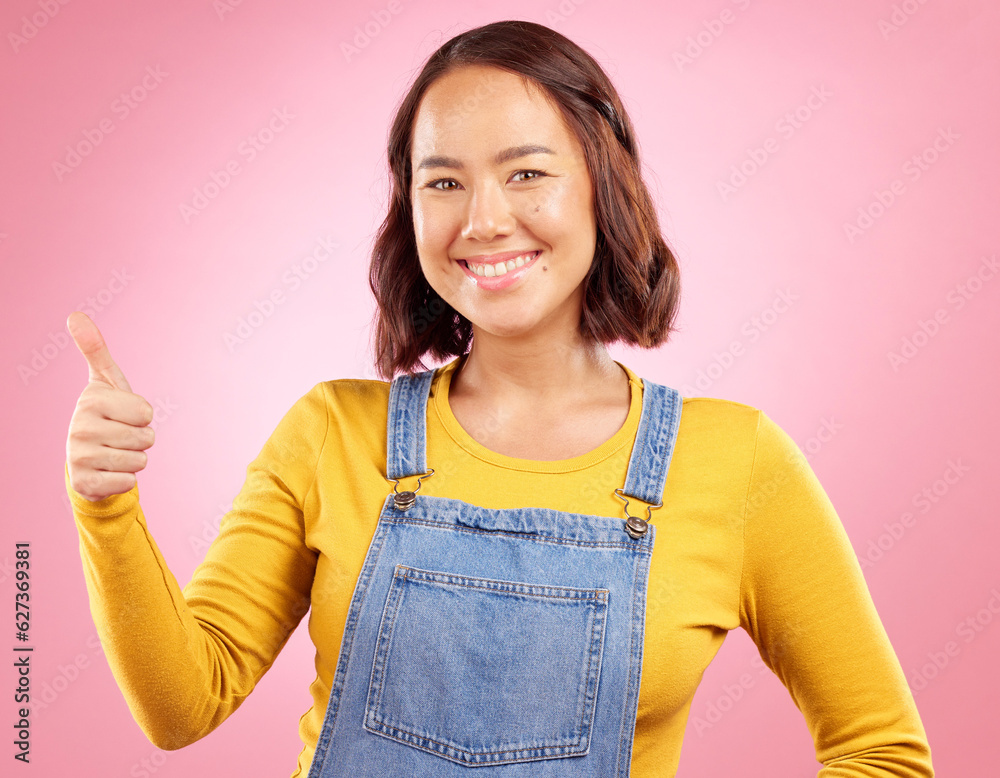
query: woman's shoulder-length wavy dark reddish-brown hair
368 21 680 380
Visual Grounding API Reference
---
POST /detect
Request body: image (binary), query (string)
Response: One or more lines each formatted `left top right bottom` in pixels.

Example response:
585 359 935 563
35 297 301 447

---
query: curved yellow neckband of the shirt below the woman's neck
431 357 642 473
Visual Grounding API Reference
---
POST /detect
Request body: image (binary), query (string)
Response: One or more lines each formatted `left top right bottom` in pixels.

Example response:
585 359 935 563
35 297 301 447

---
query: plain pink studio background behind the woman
0 0 1000 778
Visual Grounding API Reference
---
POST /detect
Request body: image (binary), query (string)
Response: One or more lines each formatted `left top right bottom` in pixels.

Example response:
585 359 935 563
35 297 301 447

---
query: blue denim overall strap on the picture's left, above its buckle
385 369 434 479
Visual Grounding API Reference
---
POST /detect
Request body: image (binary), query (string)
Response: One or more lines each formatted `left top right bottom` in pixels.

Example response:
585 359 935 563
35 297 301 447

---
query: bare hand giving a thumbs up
66 311 154 502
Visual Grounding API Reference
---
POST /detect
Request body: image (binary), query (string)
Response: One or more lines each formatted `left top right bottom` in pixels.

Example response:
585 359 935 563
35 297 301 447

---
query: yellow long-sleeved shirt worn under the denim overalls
66 360 934 778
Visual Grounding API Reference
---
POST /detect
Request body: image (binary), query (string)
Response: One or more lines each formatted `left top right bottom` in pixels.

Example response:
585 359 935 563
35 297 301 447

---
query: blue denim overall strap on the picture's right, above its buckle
622 378 683 506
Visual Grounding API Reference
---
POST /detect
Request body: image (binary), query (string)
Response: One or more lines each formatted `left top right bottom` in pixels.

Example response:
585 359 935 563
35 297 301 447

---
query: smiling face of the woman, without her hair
410 66 597 344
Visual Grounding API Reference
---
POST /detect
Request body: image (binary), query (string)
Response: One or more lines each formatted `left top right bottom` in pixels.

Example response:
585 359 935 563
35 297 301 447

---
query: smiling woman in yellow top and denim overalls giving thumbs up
66 22 933 778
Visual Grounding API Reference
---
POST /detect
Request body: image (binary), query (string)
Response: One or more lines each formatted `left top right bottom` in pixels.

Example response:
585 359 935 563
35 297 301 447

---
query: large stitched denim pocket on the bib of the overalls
364 565 608 767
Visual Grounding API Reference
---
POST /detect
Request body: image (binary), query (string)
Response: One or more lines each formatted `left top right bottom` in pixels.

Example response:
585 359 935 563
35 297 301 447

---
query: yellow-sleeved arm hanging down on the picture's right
740 412 934 778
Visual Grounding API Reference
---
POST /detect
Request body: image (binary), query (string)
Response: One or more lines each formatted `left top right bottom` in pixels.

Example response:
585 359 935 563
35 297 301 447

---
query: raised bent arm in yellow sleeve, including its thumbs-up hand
66 313 326 749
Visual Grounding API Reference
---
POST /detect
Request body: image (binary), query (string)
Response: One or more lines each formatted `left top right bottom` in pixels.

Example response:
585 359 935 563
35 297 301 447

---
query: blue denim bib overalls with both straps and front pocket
309 370 681 778
